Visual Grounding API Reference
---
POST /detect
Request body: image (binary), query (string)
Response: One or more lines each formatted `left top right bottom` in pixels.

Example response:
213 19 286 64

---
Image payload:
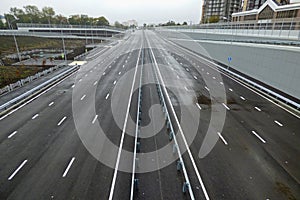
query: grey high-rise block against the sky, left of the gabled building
201 0 242 23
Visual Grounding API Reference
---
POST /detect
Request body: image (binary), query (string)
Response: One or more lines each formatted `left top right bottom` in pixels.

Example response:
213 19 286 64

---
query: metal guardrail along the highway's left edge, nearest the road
0 65 78 110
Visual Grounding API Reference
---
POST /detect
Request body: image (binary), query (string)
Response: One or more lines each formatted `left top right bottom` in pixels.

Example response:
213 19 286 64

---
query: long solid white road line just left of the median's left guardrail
109 46 142 200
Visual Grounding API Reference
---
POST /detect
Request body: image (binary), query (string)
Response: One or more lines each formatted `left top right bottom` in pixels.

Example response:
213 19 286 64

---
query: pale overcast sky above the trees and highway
0 0 202 25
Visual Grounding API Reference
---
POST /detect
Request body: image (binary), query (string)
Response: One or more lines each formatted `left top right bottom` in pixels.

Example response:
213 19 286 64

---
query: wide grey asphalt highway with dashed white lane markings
0 30 300 200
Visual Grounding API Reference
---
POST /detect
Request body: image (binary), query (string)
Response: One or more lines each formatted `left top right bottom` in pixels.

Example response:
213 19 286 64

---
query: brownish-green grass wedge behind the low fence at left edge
0 66 45 88
